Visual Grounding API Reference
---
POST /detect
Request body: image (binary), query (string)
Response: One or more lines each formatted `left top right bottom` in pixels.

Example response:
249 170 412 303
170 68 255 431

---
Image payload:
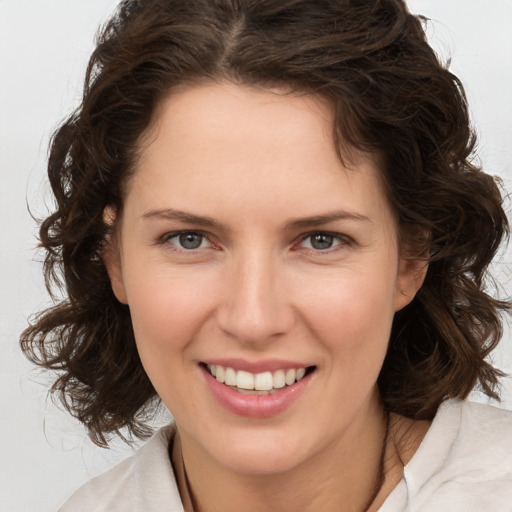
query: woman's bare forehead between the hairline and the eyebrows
125 83 396 232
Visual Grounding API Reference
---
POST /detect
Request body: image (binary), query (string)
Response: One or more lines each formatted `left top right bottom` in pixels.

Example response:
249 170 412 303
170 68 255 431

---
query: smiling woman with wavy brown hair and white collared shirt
22 0 512 511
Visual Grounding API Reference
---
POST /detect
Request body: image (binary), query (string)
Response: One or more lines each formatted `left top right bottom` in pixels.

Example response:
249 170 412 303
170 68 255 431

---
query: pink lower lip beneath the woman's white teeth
201 367 312 418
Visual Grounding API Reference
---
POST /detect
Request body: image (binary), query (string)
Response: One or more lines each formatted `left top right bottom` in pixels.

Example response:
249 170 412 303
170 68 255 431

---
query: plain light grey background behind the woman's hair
0 0 512 512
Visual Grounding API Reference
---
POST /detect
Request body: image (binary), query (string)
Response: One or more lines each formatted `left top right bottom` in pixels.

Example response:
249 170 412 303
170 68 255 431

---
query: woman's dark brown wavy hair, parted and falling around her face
21 0 510 445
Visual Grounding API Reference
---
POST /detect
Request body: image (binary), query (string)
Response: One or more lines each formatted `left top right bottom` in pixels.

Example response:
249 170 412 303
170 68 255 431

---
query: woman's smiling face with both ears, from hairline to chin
106 83 420 473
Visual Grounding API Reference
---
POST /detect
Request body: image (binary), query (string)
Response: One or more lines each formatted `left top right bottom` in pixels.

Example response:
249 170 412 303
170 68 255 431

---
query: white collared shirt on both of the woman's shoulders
60 399 512 512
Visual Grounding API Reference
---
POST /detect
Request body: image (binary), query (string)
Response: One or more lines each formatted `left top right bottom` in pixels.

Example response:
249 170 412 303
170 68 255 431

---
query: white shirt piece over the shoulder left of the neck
59 425 183 512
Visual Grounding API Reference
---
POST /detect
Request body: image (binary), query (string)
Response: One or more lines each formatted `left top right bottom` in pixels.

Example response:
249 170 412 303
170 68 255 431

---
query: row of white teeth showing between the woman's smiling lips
203 364 316 395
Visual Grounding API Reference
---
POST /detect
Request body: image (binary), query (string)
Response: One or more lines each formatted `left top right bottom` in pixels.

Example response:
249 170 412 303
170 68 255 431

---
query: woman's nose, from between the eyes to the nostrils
217 253 294 346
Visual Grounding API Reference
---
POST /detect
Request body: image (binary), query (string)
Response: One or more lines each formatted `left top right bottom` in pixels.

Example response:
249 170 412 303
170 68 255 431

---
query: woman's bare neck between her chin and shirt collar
173 401 388 512
